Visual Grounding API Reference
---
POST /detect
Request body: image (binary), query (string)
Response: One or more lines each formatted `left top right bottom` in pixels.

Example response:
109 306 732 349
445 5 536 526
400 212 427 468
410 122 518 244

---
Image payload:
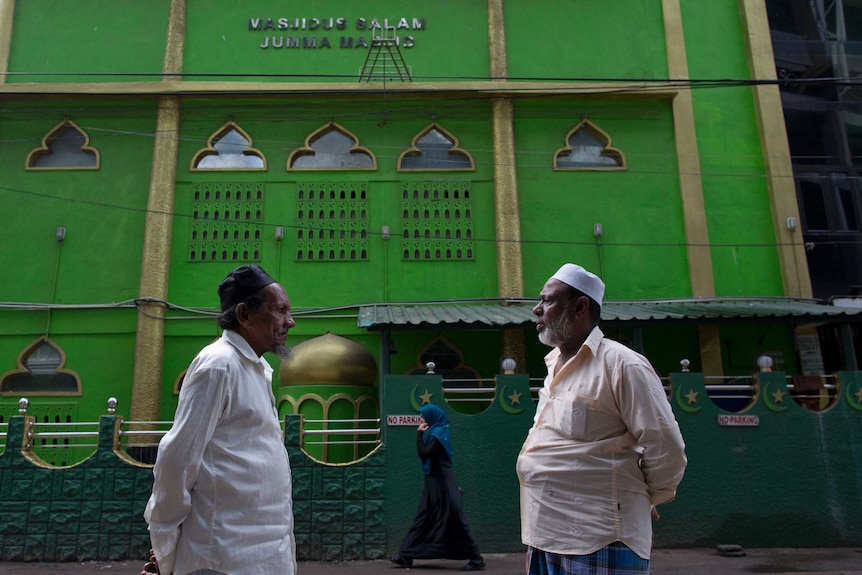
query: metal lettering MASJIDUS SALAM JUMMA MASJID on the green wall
248 18 425 48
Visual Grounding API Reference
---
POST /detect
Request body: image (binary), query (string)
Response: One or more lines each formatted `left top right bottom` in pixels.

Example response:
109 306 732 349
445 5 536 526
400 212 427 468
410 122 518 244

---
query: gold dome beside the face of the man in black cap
278 333 377 386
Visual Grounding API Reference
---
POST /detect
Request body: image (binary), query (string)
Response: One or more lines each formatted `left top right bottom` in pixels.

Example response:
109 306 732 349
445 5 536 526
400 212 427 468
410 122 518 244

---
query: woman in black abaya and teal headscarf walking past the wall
389 403 485 571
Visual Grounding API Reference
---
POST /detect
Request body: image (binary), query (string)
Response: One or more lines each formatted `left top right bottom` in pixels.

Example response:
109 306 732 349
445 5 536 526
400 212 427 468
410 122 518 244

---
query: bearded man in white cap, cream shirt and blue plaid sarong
517 264 687 575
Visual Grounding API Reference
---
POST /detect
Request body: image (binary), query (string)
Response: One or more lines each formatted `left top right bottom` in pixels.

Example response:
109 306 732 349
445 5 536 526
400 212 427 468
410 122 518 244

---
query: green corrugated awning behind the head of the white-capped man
357 297 862 330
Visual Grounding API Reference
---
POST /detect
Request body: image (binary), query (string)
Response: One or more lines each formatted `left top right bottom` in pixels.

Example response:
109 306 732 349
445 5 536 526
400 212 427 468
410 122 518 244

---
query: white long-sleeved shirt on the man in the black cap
144 330 296 575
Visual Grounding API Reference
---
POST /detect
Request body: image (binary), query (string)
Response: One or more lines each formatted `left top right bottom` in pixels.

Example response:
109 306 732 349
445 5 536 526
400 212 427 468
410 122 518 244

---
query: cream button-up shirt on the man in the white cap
517 327 686 559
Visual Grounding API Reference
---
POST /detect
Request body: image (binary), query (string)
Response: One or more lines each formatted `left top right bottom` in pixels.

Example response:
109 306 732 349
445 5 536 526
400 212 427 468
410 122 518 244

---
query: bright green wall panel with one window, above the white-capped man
515 100 691 299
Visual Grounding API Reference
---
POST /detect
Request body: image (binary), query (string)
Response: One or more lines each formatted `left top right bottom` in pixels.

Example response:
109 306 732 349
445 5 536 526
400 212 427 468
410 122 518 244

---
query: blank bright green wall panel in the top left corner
6 0 171 83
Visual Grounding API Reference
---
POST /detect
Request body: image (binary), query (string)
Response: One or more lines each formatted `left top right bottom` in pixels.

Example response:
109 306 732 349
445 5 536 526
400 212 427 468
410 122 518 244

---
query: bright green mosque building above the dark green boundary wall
0 0 859 450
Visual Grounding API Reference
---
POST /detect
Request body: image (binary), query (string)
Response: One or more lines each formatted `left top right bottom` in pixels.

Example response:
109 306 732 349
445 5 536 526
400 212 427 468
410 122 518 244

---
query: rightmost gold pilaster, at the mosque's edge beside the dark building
739 0 811 297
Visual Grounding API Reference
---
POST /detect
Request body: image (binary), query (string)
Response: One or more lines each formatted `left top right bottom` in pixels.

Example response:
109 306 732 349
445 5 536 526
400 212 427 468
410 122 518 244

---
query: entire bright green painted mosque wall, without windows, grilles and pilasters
0 0 812 436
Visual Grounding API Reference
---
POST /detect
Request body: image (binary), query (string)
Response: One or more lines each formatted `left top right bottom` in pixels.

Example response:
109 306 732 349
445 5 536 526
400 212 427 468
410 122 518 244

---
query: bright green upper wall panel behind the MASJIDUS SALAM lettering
184 0 488 82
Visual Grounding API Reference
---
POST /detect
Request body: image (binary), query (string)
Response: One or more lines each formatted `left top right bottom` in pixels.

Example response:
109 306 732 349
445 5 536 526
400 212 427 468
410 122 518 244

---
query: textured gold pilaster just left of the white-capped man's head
488 0 526 371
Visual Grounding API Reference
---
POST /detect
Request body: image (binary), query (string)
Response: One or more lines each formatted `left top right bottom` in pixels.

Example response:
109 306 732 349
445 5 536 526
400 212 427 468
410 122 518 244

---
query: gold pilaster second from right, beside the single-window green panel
662 0 724 375
